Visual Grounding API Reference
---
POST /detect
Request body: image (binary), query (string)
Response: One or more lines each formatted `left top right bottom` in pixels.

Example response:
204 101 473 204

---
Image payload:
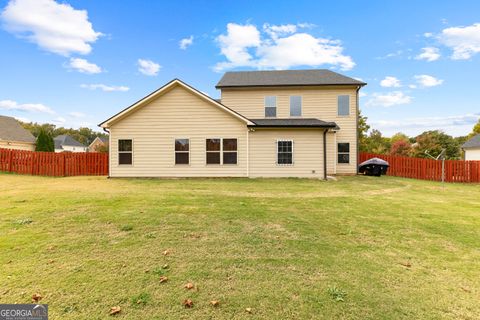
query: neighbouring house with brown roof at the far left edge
0 116 35 151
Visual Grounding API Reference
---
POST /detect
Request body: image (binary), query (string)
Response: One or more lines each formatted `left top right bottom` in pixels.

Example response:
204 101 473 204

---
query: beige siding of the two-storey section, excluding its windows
222 86 357 174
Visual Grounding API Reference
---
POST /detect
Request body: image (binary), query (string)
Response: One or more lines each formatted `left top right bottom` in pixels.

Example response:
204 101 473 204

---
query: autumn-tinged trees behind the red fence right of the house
358 113 480 160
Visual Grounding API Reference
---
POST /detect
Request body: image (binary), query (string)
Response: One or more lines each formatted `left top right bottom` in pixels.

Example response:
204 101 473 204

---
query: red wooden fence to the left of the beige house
0 149 108 177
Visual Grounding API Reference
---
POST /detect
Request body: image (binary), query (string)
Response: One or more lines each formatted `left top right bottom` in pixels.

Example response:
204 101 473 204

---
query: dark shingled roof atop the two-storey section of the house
215 69 366 89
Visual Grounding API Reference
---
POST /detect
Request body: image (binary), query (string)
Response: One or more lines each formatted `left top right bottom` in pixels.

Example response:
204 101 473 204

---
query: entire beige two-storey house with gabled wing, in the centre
99 70 365 179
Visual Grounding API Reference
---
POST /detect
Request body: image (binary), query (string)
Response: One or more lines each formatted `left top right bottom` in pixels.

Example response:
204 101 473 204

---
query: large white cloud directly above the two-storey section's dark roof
215 23 355 71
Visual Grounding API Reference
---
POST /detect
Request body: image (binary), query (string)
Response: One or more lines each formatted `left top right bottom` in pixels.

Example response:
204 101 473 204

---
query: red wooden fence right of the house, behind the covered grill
359 152 480 182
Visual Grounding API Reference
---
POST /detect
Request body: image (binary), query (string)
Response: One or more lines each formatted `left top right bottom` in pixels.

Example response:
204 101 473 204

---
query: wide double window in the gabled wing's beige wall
206 138 238 164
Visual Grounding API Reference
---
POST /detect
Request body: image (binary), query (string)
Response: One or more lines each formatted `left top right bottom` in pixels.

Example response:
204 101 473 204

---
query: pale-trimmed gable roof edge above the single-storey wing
98 79 252 128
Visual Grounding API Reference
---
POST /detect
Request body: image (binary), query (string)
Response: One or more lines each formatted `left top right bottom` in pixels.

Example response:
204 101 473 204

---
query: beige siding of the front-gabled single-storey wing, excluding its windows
110 85 247 177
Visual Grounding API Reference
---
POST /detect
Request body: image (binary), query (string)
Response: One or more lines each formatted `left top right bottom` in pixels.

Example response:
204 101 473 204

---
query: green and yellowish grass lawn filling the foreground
0 174 480 319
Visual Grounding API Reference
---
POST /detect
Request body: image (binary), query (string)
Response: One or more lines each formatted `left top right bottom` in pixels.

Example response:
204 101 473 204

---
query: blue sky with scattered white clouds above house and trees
0 0 480 135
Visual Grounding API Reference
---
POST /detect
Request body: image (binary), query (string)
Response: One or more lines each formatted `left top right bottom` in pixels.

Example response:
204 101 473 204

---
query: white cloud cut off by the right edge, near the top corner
438 23 480 60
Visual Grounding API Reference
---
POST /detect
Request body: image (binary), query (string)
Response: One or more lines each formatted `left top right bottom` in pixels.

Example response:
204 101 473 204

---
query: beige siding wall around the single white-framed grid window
249 129 323 179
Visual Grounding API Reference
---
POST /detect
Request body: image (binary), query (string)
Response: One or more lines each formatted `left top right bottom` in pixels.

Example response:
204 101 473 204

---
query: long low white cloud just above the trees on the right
370 113 480 135
